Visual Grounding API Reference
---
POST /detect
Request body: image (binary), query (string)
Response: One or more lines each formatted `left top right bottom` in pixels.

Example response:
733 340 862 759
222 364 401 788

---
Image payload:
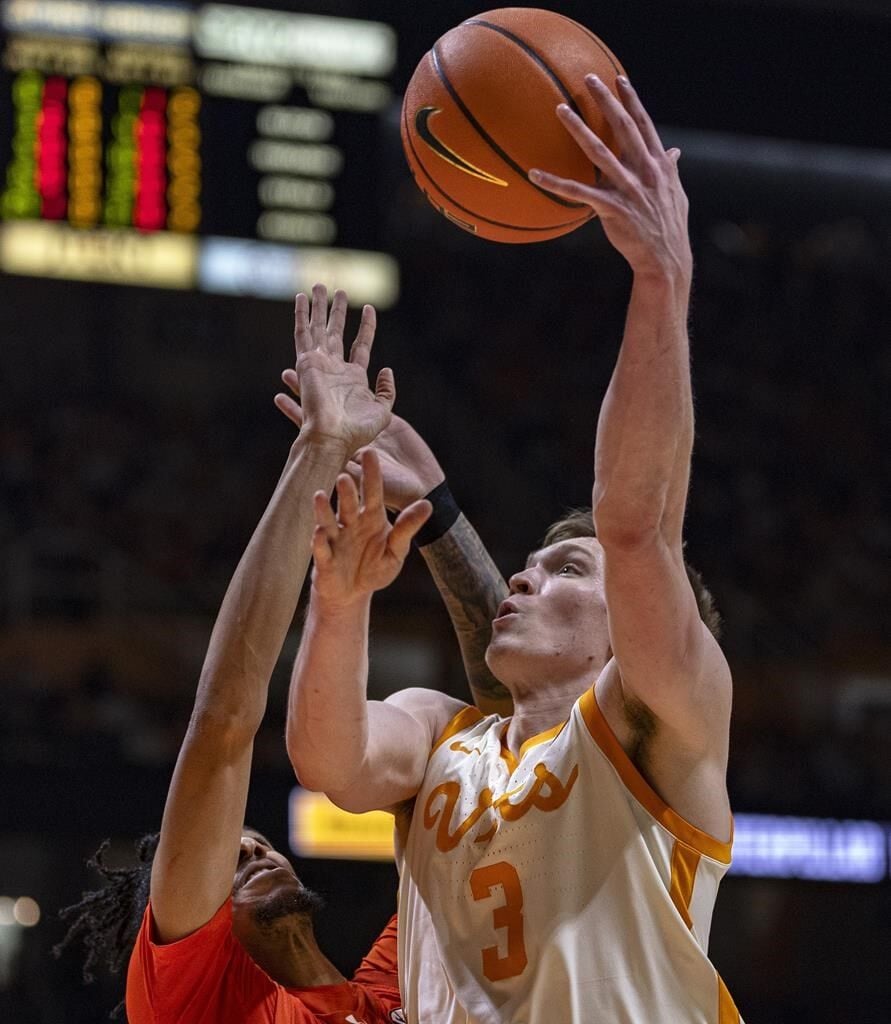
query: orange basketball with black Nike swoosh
400 7 624 242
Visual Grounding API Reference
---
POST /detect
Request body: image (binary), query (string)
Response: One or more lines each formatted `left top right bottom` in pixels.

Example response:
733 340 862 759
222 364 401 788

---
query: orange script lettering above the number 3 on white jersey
424 763 579 853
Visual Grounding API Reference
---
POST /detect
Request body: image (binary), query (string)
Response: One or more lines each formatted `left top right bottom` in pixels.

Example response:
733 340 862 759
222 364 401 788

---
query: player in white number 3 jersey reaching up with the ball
288 78 739 1024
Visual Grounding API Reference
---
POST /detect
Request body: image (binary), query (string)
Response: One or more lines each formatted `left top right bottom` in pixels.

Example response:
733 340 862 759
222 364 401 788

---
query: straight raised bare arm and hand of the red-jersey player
152 286 393 942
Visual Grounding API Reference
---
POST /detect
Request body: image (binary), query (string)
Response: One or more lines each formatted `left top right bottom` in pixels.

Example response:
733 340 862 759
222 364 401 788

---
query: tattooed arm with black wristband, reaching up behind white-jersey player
278 395 513 716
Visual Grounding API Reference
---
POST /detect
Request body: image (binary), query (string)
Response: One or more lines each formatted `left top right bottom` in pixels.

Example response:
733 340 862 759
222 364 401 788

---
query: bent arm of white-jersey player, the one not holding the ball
287 450 471 811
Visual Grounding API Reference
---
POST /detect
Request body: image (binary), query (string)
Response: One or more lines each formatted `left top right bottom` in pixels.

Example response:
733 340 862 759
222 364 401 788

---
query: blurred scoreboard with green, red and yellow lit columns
0 0 398 307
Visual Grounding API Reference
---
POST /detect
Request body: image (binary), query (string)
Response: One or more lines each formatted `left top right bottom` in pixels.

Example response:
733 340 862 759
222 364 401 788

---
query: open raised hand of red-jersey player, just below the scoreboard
275 285 396 456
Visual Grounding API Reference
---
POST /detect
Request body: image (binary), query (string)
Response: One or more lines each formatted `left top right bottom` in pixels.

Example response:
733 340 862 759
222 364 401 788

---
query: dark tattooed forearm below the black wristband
421 515 510 700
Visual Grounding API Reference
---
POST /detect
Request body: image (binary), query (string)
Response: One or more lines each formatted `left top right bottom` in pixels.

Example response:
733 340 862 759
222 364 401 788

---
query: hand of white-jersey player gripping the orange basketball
529 75 691 273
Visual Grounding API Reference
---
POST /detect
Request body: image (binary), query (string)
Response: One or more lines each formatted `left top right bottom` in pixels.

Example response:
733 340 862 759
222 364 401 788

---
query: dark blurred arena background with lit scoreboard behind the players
0 0 891 1024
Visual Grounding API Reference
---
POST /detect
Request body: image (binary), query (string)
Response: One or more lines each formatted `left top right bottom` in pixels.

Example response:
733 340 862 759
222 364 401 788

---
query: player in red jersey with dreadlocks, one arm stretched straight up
55 286 428 1024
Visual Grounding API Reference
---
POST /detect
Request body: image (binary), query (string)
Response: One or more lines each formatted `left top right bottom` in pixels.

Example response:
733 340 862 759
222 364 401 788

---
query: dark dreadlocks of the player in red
52 833 160 1017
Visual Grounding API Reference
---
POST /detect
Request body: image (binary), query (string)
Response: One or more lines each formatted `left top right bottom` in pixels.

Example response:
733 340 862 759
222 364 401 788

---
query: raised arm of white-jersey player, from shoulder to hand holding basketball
532 77 729 751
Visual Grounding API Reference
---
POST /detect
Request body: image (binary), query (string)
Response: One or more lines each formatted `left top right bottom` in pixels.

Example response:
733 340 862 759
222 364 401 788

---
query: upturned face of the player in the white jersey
485 537 609 686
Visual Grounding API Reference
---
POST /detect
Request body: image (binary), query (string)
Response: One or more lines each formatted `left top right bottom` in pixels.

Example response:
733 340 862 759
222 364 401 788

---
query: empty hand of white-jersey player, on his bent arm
312 450 431 607
